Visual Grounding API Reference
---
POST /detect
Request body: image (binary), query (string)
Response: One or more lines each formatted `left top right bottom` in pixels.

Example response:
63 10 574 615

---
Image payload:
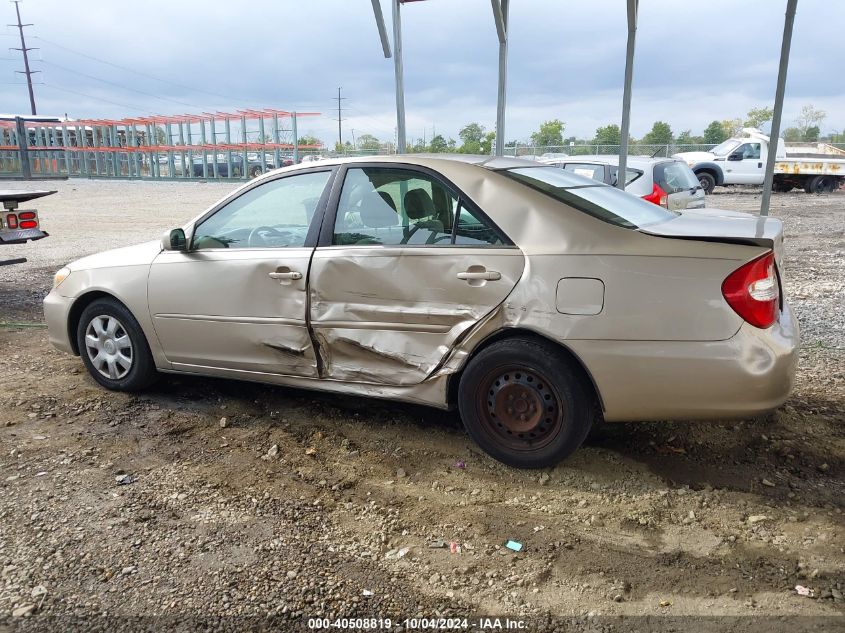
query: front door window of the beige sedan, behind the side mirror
192 171 331 250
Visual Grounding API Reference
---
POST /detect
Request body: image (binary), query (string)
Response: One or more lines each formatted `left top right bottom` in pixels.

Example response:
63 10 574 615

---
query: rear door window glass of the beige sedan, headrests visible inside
332 167 504 246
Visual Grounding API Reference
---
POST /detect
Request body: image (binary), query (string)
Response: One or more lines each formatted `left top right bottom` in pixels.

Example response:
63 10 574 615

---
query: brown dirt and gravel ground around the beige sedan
0 180 845 632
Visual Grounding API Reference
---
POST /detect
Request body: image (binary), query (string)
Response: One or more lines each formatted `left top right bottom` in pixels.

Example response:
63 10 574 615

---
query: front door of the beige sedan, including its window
148 168 333 377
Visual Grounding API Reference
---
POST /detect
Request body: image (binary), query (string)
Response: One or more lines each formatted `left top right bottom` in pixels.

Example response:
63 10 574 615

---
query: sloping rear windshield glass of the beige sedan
502 167 676 229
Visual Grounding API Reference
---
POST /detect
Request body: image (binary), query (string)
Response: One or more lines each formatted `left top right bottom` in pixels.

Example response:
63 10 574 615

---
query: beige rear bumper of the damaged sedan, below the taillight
567 304 799 422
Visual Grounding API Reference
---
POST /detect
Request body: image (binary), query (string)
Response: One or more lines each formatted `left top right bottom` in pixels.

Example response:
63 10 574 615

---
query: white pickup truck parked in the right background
672 128 845 193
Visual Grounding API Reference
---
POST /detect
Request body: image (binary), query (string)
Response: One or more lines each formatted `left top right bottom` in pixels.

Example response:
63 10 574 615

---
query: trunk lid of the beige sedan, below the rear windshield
639 209 783 264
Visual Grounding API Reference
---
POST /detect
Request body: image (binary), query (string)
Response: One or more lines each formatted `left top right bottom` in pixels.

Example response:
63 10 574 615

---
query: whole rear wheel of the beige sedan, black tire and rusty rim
458 338 594 468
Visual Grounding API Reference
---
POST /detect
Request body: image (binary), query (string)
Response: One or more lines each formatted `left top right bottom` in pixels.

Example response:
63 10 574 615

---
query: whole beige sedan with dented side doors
44 155 798 467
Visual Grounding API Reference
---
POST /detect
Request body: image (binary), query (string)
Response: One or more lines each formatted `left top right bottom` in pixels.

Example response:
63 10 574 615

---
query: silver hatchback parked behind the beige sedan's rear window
543 155 704 210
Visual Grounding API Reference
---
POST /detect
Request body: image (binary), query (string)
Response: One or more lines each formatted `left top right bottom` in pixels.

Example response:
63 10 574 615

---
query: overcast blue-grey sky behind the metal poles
0 0 845 144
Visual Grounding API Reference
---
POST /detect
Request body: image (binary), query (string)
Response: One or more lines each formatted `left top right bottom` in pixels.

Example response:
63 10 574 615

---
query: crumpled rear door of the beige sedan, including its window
310 164 524 385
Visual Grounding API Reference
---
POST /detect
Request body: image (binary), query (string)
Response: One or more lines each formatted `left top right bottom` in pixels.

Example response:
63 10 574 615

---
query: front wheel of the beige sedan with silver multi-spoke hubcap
76 298 158 391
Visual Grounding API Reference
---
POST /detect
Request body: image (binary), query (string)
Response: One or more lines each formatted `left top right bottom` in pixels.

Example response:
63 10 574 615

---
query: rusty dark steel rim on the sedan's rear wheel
476 365 564 451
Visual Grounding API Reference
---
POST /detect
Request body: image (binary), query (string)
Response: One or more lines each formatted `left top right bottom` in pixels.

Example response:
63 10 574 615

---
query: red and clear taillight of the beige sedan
722 251 780 328
